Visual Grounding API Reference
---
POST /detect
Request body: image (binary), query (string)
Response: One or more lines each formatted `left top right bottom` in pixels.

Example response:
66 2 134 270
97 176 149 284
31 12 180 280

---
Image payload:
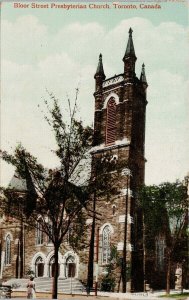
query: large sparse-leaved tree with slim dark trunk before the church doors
1 90 93 299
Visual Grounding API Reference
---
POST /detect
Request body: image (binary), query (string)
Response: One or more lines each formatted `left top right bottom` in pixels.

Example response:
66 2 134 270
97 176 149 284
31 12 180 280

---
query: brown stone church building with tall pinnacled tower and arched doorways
0 29 148 291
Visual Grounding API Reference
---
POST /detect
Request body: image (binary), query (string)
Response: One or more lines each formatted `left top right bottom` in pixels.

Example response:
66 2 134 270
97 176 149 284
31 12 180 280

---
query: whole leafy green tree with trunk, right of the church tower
139 181 188 294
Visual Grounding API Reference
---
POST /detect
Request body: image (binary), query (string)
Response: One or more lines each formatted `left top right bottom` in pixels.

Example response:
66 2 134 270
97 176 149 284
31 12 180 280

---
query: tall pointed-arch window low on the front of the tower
102 225 111 264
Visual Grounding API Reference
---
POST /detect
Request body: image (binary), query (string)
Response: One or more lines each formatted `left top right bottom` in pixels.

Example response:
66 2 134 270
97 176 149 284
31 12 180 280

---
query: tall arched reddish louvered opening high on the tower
106 98 116 145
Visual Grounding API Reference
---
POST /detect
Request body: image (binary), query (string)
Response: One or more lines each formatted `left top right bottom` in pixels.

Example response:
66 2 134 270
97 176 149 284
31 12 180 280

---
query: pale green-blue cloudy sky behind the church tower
0 1 189 186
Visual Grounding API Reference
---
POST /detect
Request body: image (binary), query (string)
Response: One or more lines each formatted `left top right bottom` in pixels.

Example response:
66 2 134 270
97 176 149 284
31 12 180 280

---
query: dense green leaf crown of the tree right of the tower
139 181 188 245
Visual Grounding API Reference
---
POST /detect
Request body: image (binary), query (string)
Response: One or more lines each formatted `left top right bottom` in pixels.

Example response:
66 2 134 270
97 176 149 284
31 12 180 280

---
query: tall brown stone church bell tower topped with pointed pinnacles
92 28 148 292
